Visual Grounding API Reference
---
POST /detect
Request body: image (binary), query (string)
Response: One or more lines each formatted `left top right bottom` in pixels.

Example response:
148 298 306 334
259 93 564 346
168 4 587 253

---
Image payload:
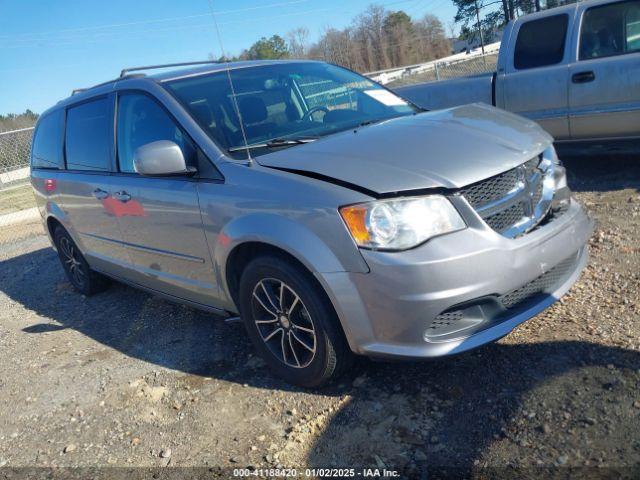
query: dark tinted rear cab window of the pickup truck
513 14 569 70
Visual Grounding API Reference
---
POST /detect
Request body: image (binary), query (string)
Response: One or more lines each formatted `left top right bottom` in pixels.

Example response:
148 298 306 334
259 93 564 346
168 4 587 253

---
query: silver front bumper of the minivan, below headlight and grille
318 200 593 358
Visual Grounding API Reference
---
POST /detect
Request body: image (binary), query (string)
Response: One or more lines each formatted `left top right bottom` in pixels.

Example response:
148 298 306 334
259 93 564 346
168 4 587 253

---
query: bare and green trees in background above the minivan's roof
226 0 577 72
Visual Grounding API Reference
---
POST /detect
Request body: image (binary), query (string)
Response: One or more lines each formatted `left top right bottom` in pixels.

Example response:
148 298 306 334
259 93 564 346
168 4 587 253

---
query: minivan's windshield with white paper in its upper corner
166 62 417 158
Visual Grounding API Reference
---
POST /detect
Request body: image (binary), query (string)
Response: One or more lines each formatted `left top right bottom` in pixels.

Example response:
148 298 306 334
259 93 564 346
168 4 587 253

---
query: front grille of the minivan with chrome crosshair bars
460 155 554 238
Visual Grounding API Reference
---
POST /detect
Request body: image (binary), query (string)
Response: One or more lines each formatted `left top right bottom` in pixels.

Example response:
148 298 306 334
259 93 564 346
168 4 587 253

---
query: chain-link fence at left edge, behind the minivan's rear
0 127 44 249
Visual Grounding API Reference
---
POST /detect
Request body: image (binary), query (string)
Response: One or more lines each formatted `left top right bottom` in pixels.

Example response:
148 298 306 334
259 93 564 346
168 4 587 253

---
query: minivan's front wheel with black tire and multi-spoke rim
239 255 353 387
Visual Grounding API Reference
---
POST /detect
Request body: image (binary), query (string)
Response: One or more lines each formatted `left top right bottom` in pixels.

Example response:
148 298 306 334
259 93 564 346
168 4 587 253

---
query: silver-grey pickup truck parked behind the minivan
395 0 640 142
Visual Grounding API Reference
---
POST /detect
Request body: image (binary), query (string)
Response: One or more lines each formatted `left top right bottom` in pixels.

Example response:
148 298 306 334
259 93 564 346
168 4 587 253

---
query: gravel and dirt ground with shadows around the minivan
0 157 640 478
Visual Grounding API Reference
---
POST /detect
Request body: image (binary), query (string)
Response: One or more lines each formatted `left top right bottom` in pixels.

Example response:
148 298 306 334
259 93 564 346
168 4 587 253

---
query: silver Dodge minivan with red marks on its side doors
31 61 592 386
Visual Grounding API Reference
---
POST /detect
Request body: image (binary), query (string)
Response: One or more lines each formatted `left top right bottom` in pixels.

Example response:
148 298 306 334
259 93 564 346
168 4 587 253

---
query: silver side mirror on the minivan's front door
133 140 196 176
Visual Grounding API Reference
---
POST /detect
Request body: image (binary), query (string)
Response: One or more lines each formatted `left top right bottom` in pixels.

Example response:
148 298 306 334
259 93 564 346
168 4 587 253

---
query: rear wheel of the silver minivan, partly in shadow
53 227 109 296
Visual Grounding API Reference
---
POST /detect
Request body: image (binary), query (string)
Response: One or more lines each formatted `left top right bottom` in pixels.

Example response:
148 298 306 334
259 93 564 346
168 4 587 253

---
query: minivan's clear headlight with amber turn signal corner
340 195 466 250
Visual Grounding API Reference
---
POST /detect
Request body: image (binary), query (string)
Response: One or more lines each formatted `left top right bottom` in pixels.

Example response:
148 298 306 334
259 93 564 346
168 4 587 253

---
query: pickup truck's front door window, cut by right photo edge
580 0 640 60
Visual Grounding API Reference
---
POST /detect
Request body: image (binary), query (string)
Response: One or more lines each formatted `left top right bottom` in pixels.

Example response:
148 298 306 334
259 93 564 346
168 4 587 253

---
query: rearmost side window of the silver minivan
31 110 64 169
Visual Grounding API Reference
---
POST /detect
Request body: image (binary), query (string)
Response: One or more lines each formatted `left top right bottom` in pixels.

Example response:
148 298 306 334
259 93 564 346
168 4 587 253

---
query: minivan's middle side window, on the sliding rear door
65 98 111 172
